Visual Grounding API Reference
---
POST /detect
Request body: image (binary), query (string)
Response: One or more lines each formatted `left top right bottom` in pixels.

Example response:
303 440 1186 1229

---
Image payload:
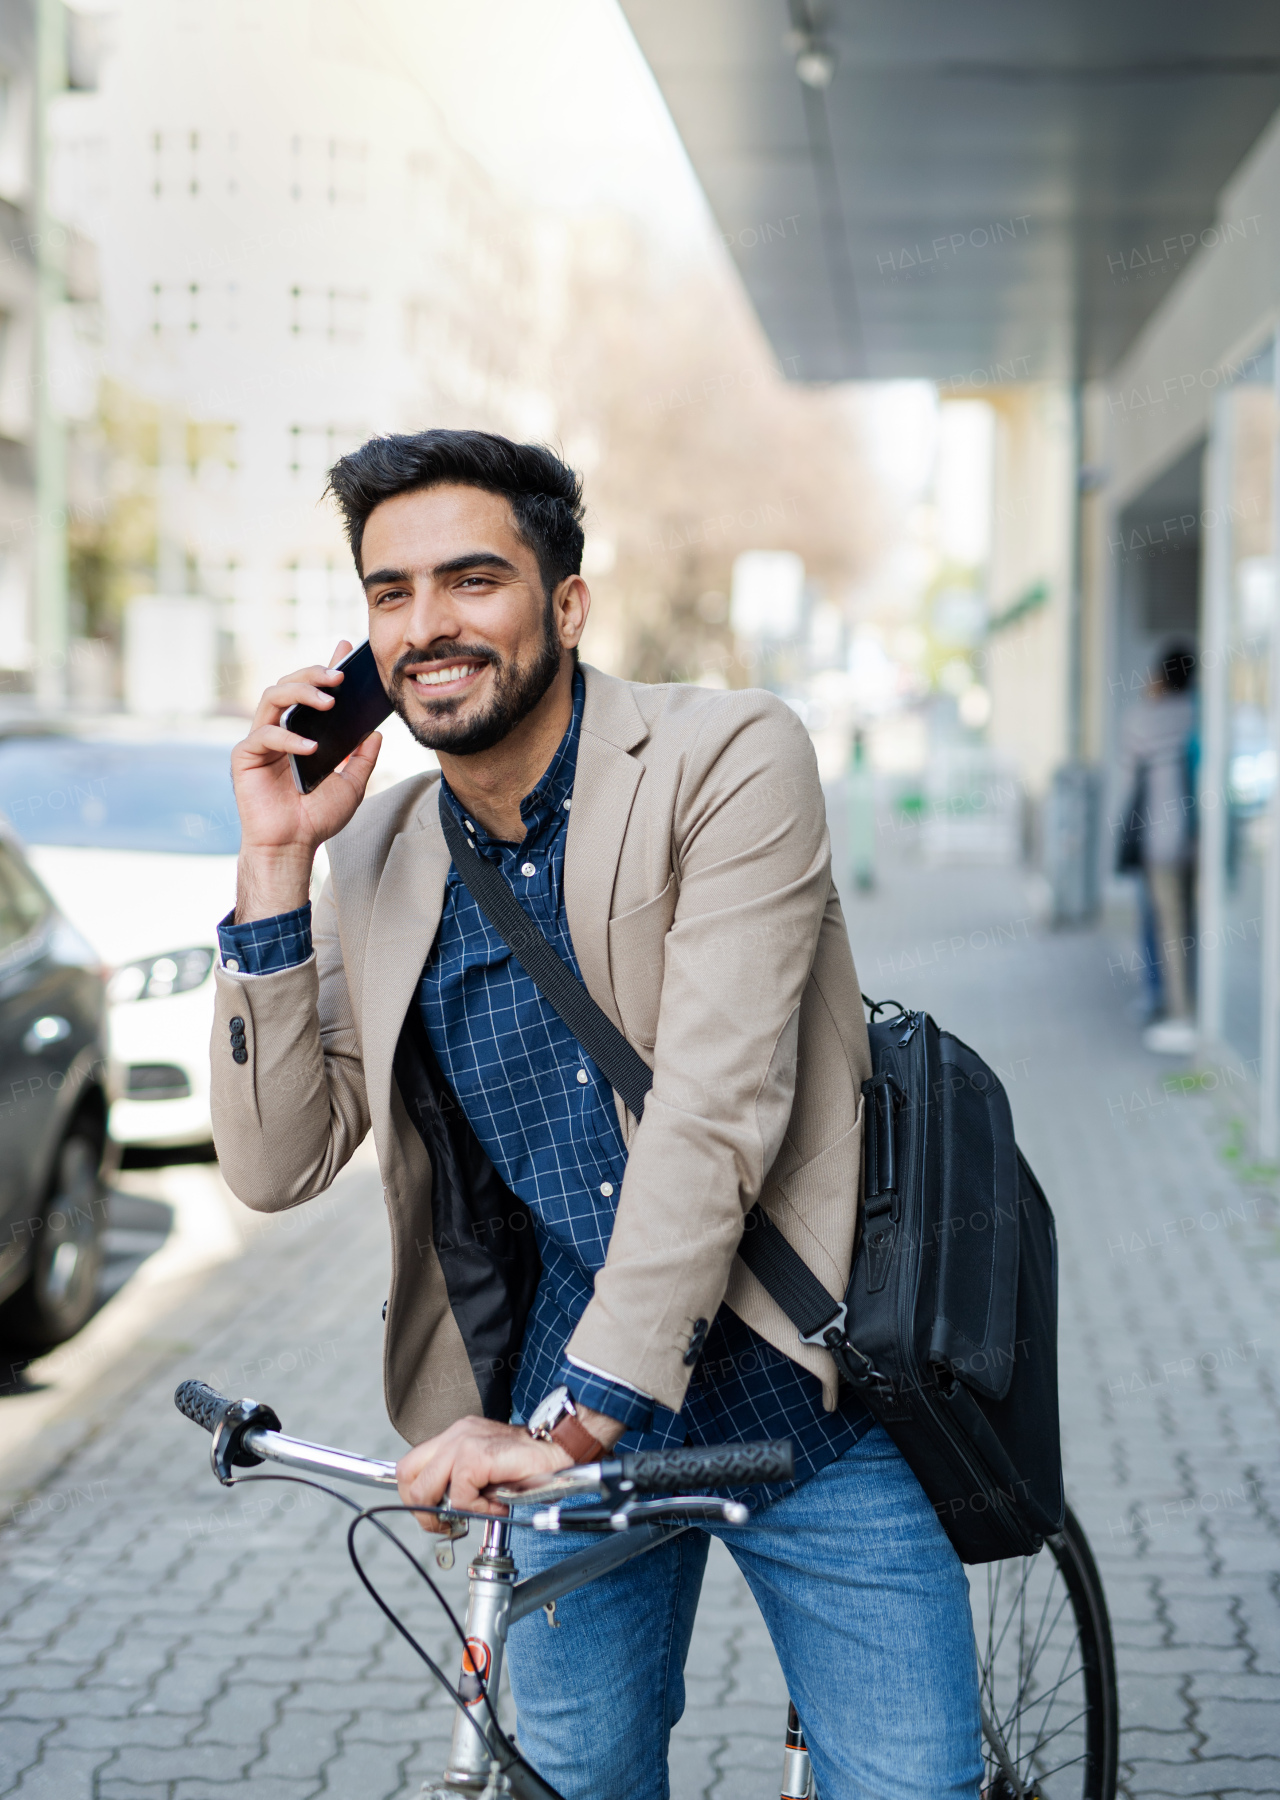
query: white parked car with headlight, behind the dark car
0 734 239 1147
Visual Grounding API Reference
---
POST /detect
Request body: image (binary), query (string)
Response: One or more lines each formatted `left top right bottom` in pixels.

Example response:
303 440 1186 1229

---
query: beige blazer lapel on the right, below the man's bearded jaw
565 668 648 1030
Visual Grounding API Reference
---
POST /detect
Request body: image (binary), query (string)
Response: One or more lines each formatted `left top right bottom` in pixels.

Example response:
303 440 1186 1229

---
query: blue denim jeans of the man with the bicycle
508 1426 981 1800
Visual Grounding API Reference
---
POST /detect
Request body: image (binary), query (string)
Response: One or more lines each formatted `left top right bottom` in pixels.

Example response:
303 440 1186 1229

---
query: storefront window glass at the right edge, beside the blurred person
1222 346 1276 1058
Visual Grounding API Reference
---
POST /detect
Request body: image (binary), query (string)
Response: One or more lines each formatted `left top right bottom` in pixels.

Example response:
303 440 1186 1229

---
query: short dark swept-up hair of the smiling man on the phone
324 430 583 599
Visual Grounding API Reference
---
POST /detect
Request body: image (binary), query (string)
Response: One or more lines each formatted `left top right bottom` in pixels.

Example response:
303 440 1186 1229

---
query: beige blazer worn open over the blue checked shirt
211 668 871 1442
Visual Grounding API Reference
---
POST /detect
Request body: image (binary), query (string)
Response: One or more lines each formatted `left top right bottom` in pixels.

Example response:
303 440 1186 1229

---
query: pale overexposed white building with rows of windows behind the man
56 0 549 706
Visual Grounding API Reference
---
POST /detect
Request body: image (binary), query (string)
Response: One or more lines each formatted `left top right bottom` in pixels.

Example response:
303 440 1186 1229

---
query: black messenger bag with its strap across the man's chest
439 796 1066 1562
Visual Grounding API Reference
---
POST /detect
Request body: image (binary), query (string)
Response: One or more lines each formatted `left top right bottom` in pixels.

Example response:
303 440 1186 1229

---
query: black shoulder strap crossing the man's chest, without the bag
439 788 856 1350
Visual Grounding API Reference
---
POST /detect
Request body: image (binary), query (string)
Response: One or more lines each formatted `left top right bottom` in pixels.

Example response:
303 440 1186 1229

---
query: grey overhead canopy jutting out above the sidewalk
621 0 1280 385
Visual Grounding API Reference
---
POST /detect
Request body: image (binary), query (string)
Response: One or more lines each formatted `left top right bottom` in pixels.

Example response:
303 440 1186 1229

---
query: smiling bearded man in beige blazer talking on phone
212 430 979 1800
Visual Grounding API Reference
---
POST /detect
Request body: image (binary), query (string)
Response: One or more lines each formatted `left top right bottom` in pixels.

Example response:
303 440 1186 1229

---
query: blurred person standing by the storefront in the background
1120 643 1199 1057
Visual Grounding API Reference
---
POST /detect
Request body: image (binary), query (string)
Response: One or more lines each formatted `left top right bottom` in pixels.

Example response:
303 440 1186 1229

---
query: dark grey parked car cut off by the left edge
0 833 108 1350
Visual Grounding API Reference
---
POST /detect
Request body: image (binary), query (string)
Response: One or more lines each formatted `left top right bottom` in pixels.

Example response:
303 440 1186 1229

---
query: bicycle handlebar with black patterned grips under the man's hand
173 1381 794 1501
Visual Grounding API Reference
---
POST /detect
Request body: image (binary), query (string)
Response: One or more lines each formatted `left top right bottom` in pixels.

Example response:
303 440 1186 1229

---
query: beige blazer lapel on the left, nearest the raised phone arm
362 783 450 1141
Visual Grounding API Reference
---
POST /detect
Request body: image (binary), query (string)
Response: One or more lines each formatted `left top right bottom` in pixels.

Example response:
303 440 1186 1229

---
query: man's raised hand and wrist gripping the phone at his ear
230 643 391 920
